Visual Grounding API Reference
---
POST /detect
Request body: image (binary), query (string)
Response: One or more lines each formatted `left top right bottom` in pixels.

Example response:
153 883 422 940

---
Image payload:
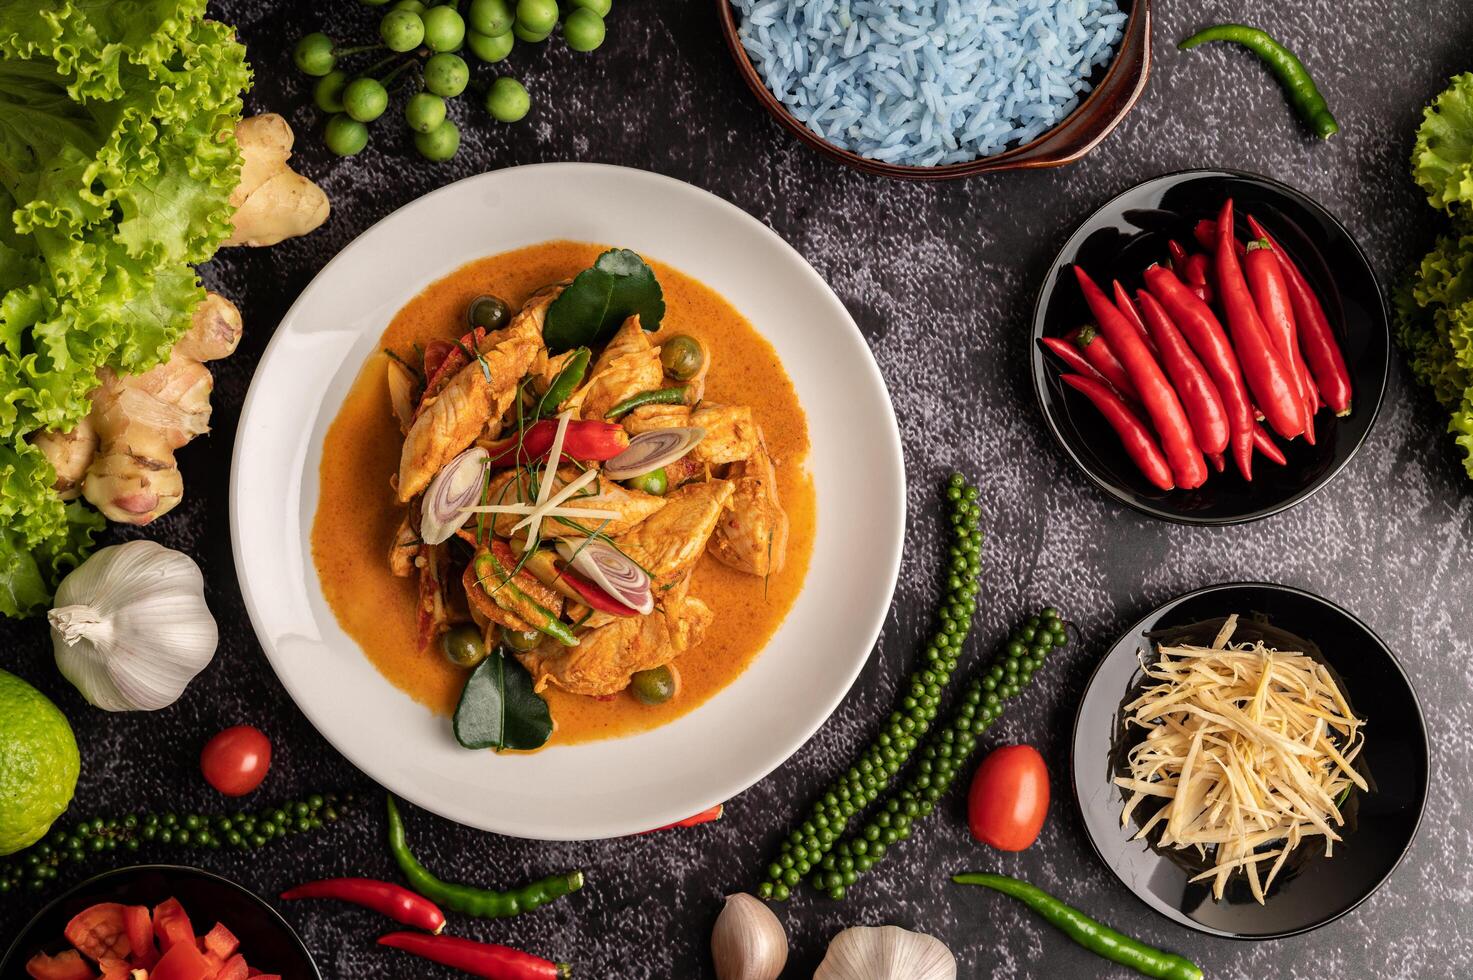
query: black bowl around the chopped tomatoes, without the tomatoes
0 865 323 980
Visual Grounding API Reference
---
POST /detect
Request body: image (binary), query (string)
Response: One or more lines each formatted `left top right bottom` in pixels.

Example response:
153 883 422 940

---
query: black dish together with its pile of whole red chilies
1033 171 1391 525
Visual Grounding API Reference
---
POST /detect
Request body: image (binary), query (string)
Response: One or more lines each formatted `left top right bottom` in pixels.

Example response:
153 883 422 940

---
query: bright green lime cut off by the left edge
0 671 81 855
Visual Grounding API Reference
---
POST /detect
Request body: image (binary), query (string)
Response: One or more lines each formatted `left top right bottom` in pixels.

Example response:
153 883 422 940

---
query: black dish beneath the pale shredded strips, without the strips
1069 584 1427 939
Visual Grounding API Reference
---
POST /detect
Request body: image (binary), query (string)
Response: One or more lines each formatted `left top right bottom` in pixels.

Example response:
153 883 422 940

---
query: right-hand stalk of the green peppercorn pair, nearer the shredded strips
810 607 1069 899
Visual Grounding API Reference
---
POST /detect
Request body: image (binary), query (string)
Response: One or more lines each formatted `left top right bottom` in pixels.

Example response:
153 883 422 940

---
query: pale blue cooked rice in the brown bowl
732 0 1125 167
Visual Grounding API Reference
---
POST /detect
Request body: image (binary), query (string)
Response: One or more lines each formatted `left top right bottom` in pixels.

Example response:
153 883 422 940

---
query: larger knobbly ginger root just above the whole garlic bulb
35 293 243 525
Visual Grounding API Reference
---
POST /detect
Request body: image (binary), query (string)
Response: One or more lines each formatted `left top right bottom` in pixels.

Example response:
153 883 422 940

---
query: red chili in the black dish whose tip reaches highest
1215 197 1304 439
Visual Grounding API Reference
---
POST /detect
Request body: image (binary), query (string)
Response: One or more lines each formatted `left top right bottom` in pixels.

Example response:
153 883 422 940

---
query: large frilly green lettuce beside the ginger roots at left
0 0 250 616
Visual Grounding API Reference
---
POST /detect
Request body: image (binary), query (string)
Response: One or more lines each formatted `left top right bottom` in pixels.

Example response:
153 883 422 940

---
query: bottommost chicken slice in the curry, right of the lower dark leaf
517 597 716 697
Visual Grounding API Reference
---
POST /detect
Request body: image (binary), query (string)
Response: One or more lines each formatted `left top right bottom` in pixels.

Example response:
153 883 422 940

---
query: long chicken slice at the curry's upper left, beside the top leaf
398 287 560 503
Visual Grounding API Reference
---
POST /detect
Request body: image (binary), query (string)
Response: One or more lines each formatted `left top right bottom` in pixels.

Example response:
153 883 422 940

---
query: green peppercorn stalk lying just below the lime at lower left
0 793 354 895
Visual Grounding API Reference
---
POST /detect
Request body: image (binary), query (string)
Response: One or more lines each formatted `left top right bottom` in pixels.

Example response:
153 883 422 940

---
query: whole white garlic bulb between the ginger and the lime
47 541 219 712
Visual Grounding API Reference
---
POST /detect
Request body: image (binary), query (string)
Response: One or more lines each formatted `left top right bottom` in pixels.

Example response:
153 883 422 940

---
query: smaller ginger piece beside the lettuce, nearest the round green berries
225 112 330 245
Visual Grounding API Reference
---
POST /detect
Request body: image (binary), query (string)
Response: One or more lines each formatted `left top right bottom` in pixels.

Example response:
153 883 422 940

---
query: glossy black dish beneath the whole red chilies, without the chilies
1030 169 1391 525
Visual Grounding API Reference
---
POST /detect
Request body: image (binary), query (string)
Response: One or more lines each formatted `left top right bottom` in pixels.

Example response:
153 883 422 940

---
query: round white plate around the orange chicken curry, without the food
230 164 904 840
